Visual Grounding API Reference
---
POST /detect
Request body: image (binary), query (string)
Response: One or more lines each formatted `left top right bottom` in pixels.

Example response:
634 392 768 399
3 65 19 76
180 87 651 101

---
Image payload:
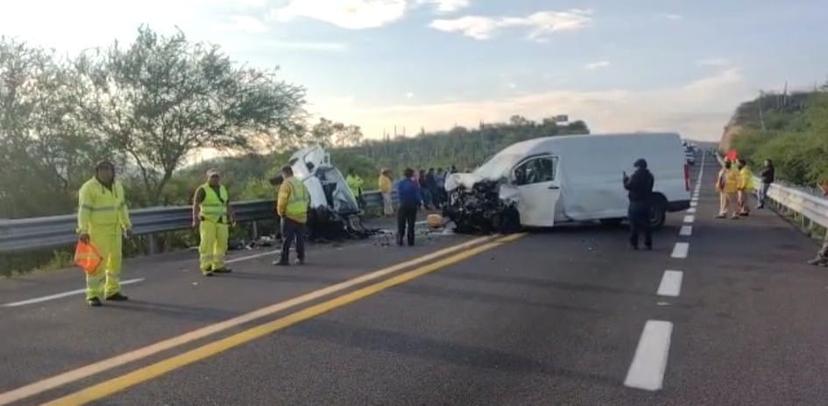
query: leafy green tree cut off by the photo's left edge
0 37 105 217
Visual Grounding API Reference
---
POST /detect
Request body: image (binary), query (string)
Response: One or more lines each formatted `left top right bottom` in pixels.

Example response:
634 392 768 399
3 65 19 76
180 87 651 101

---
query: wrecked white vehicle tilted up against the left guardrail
288 146 369 240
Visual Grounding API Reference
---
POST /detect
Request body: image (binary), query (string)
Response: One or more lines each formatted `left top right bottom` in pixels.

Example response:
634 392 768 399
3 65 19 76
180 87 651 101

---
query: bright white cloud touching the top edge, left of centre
270 0 406 30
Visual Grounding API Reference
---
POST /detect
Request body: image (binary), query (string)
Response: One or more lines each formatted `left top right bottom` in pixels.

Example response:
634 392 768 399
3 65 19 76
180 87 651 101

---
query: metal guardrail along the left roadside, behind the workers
0 191 388 253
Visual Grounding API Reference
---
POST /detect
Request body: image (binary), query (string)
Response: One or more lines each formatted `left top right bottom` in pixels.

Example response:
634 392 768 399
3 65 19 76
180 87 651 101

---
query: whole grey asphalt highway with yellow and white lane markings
0 151 828 405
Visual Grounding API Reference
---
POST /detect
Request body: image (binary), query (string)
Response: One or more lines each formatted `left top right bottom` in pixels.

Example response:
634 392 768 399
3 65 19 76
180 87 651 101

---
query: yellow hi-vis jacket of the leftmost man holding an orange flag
78 178 132 233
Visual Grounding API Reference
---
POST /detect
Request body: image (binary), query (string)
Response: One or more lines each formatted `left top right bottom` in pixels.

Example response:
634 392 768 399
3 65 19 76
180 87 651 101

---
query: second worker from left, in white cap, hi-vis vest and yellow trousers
193 169 235 276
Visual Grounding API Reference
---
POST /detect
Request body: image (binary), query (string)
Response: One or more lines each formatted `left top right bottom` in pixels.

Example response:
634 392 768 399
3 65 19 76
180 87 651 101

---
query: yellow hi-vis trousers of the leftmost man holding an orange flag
86 225 123 300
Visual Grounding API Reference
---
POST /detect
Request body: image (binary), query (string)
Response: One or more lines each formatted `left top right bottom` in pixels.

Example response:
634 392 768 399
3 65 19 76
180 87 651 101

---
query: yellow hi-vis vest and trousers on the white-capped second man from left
197 183 230 274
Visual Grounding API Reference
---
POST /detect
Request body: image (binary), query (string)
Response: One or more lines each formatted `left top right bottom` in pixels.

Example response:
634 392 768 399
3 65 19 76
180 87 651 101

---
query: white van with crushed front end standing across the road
445 133 690 232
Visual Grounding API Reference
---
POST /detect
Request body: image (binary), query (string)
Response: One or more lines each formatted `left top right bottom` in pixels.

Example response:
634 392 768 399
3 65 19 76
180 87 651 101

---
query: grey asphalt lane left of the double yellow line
0 217 478 399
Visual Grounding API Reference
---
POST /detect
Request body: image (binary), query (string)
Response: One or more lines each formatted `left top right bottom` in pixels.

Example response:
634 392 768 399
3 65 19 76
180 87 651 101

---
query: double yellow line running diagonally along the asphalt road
8 234 523 405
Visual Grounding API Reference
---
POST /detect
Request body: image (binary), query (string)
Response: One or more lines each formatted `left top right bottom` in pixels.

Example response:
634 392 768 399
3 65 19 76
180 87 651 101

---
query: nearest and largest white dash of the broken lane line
624 320 673 391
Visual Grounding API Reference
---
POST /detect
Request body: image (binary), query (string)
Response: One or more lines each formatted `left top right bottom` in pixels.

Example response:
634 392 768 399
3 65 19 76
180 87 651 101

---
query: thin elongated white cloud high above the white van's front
429 9 592 42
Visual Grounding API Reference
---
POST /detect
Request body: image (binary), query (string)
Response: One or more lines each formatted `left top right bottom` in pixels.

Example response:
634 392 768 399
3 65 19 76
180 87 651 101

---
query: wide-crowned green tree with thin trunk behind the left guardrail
76 27 304 204
